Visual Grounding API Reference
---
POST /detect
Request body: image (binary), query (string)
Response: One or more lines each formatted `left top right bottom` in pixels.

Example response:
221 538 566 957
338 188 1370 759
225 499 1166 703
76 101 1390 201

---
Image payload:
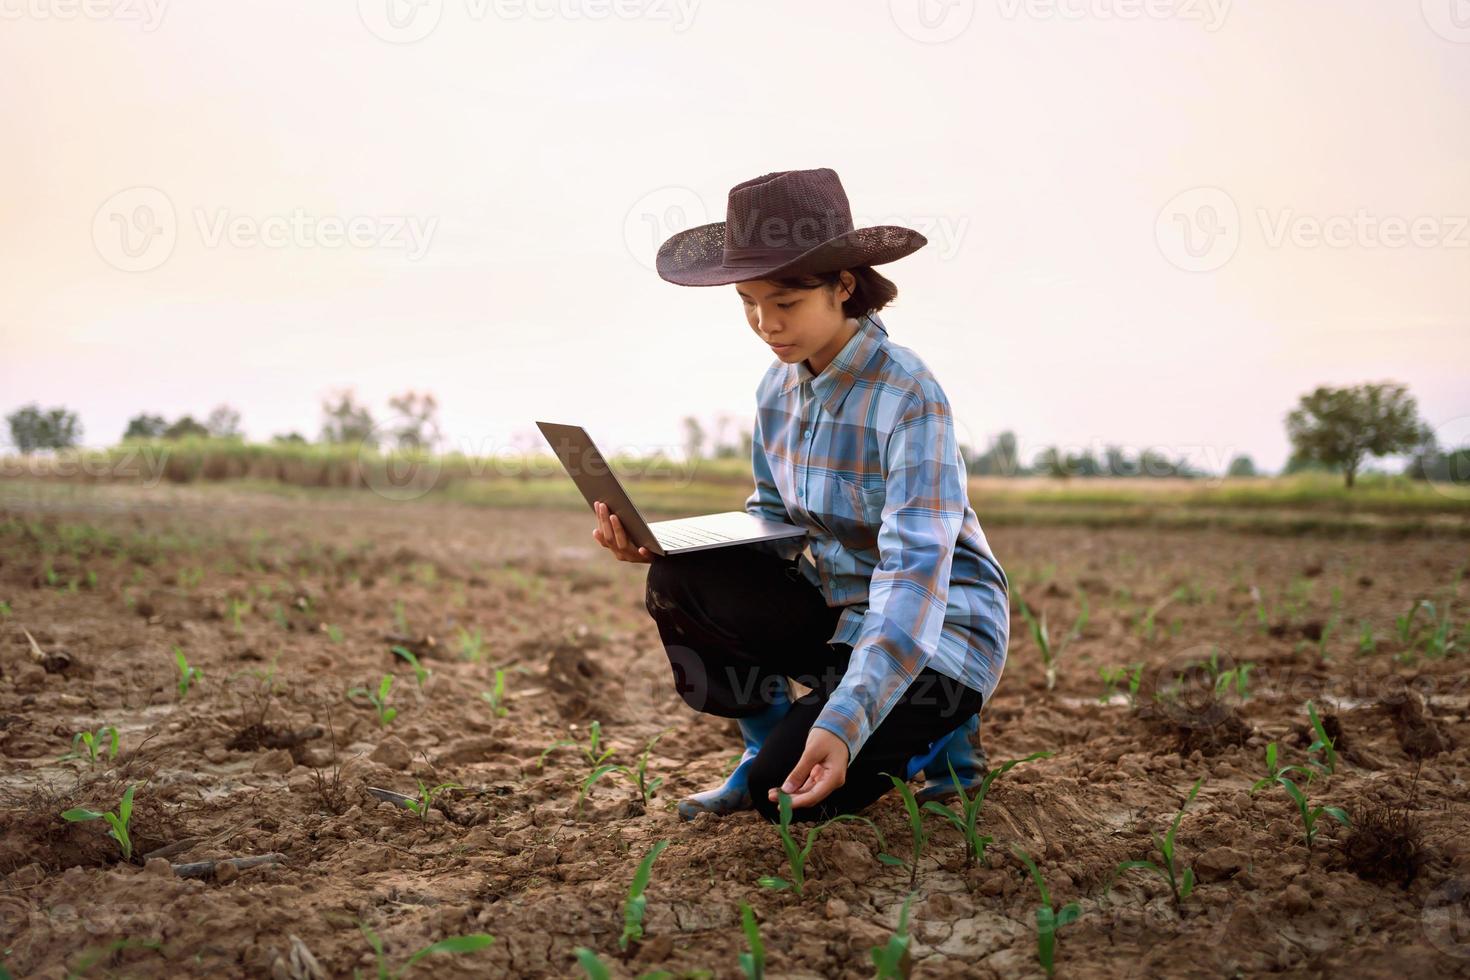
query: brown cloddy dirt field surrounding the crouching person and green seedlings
0 488 1470 977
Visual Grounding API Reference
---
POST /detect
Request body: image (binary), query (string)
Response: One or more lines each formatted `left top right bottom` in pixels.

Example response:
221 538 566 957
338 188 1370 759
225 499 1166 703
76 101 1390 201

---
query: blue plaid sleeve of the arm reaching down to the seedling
805 389 969 763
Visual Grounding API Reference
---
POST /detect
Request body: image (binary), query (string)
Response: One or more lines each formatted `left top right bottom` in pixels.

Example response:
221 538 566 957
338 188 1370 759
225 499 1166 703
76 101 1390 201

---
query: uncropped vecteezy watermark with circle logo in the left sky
91 185 440 272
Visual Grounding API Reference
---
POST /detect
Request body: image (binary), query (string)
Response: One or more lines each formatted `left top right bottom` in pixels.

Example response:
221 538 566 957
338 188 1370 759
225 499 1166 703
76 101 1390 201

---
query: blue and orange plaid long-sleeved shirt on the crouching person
745 313 1010 761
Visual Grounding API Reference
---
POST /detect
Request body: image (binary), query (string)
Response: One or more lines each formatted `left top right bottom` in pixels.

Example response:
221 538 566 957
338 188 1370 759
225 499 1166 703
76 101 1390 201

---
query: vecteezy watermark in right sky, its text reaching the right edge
1154 187 1470 272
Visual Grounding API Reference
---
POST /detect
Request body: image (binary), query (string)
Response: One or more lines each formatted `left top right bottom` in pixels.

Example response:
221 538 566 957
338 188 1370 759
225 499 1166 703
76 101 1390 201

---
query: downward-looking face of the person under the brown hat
735 273 856 375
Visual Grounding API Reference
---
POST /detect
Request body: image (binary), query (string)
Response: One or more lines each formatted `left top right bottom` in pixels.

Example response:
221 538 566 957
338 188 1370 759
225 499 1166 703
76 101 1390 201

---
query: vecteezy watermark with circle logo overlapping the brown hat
623 187 970 270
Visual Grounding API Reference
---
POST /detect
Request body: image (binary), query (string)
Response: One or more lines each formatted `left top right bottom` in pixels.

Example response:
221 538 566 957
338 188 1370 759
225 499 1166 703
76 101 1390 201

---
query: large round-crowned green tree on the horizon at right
1286 382 1433 488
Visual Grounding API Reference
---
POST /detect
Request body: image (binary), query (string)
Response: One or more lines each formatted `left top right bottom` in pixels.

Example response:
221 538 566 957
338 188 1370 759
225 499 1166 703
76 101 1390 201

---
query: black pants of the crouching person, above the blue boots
647 547 982 823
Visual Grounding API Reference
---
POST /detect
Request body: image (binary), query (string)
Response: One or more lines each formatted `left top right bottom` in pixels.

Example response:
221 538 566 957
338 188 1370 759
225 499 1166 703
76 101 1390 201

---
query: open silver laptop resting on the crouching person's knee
537 422 807 555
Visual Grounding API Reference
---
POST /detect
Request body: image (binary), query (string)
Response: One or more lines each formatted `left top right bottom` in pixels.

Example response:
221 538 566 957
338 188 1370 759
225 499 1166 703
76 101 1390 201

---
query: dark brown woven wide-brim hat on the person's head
657 167 929 287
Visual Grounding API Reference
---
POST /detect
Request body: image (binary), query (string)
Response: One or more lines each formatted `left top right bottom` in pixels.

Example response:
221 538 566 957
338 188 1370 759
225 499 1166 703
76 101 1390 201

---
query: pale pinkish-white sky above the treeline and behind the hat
0 0 1470 469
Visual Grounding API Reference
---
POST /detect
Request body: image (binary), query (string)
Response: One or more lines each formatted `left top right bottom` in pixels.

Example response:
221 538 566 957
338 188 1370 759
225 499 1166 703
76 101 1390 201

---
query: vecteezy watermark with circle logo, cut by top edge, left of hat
357 0 700 44
